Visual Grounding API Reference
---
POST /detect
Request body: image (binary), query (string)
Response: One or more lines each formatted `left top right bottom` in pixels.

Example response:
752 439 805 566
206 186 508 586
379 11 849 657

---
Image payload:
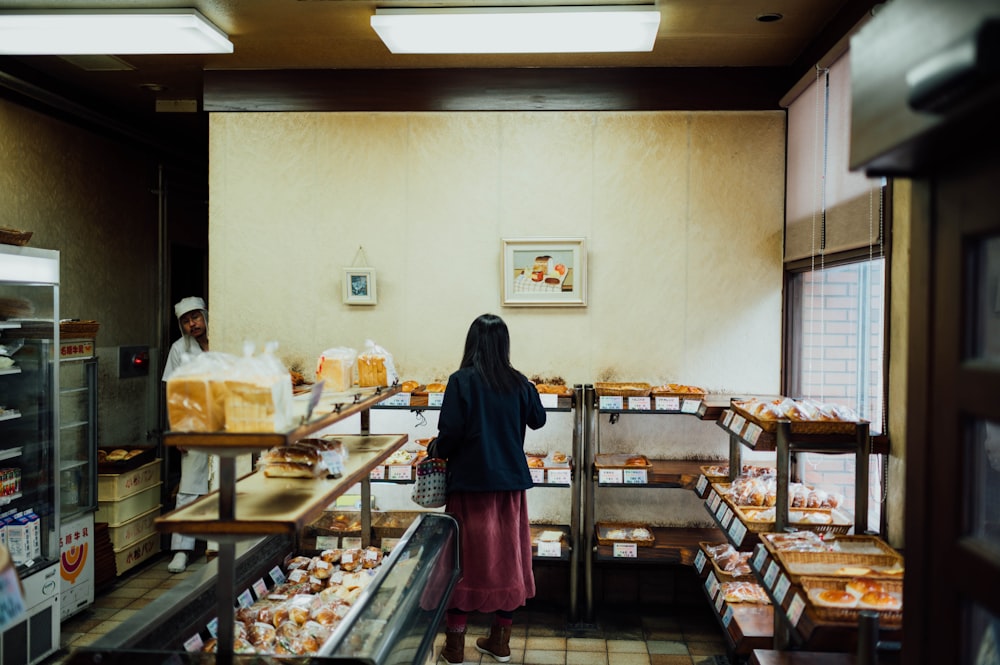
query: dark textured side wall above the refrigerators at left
0 100 158 445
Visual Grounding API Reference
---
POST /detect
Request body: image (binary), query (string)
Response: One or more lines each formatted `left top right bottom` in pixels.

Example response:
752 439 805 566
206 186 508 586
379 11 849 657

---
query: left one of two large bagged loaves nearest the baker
167 351 236 432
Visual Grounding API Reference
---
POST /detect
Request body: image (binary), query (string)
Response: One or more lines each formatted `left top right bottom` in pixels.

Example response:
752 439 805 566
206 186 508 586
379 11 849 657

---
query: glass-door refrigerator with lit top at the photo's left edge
0 245 60 665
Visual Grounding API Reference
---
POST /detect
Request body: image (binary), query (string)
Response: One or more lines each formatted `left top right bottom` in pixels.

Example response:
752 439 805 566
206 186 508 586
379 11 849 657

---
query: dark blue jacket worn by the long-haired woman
428 367 545 493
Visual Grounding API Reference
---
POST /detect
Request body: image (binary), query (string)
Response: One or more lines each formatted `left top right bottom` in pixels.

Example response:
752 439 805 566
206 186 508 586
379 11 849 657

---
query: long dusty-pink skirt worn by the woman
445 490 535 613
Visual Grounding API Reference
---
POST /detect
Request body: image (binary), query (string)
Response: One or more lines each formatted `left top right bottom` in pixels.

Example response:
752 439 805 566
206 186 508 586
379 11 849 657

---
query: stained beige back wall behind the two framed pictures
209 112 784 392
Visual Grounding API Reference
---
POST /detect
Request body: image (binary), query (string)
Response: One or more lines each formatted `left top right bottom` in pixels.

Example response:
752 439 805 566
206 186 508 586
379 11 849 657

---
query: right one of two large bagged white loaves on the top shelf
225 342 293 432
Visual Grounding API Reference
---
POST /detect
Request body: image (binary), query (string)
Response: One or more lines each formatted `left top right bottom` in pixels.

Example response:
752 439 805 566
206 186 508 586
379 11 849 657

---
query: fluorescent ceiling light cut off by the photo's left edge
0 9 233 55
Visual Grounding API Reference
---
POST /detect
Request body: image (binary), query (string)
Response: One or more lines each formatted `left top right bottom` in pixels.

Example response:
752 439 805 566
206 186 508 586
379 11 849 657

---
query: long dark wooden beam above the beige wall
204 67 788 112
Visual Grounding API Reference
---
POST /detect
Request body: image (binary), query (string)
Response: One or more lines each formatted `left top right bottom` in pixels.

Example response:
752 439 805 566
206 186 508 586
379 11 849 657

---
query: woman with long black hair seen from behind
428 314 545 663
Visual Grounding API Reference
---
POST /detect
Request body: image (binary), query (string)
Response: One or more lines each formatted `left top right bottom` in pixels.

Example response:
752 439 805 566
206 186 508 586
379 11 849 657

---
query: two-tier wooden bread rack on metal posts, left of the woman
156 386 407 657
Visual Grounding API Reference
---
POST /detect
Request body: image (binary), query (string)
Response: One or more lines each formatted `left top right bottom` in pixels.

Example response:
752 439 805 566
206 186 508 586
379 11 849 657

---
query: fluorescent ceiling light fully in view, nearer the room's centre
371 5 660 53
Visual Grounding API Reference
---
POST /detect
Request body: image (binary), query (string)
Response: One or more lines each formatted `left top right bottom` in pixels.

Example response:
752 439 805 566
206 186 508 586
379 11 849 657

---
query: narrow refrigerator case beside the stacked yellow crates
59 339 97 620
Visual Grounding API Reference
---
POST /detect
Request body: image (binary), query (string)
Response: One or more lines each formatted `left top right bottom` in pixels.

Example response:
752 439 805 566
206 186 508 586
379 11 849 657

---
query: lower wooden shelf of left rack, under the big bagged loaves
156 434 407 540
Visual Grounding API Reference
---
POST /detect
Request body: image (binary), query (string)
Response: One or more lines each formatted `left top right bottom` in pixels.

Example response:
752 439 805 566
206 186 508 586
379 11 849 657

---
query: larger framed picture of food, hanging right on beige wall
500 238 587 307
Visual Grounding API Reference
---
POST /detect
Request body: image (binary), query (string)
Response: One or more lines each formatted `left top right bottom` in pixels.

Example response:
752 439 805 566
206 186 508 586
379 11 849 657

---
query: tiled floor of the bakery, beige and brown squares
45 555 729 665
